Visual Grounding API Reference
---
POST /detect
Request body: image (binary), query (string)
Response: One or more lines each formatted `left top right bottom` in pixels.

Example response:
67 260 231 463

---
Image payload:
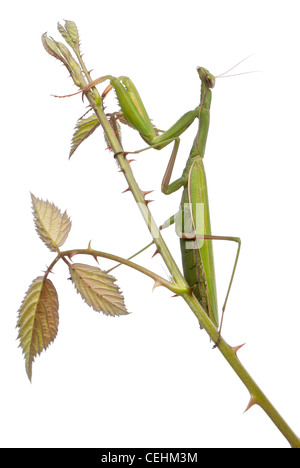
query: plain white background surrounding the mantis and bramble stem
0 0 300 448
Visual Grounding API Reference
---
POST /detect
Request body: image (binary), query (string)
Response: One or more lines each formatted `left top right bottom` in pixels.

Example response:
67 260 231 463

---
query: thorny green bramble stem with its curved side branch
45 28 300 448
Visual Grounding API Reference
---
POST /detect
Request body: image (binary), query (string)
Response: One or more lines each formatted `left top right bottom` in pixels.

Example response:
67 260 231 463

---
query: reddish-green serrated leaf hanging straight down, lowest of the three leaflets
17 276 59 380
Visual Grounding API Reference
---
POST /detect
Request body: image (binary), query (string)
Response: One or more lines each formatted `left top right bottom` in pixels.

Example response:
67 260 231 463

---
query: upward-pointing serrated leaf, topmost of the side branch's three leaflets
31 194 71 252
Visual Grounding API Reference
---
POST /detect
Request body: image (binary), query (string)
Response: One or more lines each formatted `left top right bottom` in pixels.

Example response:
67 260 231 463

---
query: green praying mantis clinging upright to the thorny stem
83 67 241 336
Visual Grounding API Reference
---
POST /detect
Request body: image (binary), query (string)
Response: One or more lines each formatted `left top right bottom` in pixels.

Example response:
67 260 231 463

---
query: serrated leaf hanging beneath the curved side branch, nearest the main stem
70 263 128 315
